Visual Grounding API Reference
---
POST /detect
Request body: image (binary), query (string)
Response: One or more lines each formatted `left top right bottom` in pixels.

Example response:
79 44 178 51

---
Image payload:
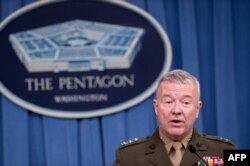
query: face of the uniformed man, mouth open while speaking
153 81 202 140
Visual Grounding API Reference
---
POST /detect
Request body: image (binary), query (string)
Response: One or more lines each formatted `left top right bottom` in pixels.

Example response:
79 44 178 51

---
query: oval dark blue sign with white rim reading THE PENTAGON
0 0 172 118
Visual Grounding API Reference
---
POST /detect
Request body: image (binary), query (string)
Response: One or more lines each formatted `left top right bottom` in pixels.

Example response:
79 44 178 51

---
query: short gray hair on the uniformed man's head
156 69 200 99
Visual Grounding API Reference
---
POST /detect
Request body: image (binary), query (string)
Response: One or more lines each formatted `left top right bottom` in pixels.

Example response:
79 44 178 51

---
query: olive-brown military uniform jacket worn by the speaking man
114 129 236 166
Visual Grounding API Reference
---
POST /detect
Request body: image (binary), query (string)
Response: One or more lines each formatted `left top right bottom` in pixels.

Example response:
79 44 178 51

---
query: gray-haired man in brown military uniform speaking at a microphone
114 70 236 166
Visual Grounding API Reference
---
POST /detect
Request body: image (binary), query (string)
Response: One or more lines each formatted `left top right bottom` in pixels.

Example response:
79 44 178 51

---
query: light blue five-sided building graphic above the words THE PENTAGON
9 20 144 72
